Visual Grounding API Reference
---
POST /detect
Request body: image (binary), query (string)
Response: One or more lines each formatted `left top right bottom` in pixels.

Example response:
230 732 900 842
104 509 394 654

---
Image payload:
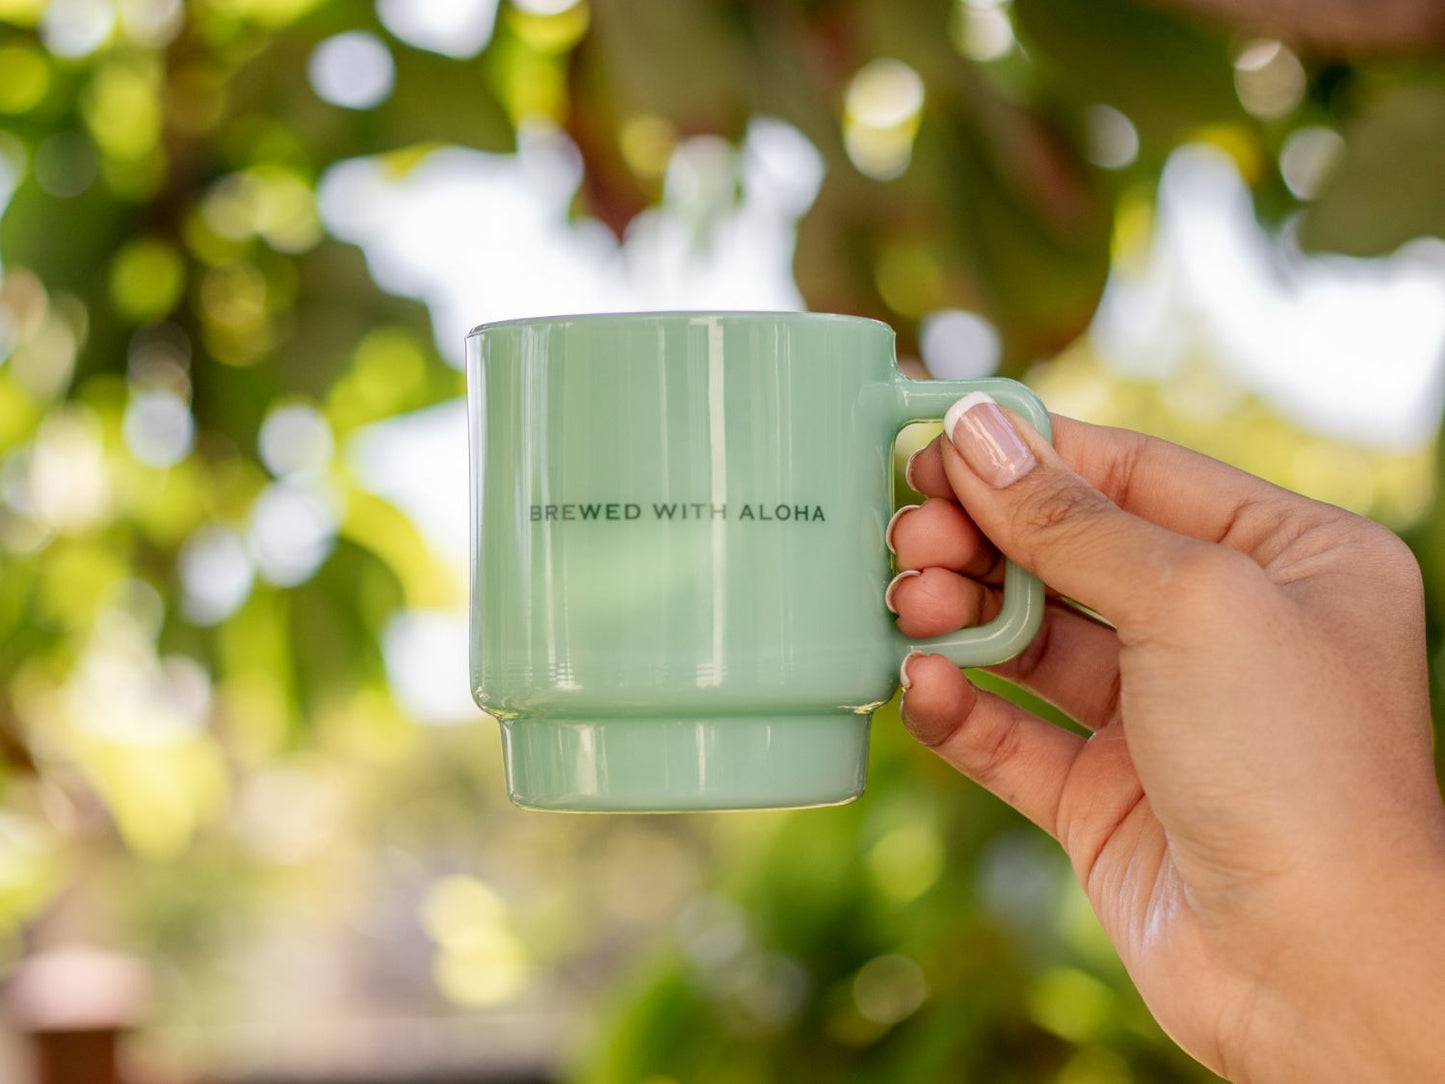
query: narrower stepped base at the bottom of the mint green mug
501 713 868 812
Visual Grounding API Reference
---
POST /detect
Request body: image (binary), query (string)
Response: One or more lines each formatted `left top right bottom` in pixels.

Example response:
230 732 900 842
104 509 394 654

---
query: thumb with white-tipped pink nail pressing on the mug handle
939 392 1217 626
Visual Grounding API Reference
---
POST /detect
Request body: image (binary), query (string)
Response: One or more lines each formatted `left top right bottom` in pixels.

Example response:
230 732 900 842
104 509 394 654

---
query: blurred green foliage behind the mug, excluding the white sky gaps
0 0 1445 1084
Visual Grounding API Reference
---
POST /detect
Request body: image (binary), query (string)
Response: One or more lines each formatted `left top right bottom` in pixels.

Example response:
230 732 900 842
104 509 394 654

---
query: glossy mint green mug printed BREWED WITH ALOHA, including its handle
467 312 1049 811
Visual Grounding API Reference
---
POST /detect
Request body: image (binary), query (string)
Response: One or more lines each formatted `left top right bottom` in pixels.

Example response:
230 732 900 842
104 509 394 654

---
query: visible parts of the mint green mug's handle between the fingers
894 376 1053 666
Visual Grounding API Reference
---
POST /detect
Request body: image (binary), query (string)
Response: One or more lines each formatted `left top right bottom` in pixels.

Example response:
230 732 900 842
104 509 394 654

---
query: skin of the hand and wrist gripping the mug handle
893 418 1445 1083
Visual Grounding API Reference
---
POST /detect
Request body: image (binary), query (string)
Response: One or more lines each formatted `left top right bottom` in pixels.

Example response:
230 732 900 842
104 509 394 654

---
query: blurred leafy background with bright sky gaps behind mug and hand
0 0 1445 1084
